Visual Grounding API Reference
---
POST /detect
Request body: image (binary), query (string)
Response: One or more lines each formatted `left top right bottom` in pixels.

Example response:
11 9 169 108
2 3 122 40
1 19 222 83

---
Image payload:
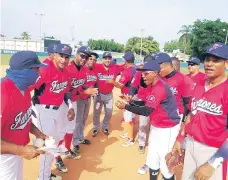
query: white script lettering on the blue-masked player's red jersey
10 106 32 130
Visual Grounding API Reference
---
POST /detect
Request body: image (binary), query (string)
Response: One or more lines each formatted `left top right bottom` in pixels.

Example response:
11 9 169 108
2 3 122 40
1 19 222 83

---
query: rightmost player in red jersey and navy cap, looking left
173 42 228 180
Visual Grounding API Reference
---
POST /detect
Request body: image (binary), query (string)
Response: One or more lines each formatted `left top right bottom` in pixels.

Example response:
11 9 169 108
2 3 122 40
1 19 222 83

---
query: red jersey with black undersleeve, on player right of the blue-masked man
33 62 70 106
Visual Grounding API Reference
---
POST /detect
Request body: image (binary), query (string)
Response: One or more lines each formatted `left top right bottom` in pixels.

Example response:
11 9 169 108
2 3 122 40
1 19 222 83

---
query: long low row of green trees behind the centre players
88 39 124 52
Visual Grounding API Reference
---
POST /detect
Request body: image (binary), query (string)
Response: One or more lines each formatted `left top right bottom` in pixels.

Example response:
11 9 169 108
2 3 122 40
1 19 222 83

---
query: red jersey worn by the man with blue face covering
0 78 32 146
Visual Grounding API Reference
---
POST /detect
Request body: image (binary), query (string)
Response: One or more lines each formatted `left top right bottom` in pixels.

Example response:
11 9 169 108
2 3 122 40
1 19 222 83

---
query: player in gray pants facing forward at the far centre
93 52 123 137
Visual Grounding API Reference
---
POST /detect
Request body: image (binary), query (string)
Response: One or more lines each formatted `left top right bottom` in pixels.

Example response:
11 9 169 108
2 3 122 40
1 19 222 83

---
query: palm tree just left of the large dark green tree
177 25 192 53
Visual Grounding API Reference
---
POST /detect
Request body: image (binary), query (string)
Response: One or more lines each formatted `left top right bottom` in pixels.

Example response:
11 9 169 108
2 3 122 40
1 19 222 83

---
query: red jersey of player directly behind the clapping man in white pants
163 71 194 114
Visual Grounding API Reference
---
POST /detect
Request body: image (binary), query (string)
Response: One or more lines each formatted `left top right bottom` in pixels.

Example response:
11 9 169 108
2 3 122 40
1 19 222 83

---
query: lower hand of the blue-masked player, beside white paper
17 145 45 160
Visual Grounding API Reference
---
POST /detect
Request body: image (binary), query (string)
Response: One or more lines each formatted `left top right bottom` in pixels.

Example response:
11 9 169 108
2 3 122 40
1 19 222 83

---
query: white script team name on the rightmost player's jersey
192 98 223 115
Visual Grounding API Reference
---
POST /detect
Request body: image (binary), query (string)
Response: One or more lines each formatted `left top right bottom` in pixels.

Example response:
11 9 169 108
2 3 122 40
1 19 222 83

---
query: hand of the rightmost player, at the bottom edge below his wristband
194 163 215 180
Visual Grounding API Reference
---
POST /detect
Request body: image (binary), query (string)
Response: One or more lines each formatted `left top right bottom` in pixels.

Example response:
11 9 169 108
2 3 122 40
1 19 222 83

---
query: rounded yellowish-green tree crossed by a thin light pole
125 36 159 56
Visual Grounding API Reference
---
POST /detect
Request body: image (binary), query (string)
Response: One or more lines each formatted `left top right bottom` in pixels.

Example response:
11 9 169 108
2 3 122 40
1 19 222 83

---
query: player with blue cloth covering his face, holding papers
0 51 47 180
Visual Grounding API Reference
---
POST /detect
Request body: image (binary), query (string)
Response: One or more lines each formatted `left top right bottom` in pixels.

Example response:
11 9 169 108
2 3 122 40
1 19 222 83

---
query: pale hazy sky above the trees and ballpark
0 0 228 48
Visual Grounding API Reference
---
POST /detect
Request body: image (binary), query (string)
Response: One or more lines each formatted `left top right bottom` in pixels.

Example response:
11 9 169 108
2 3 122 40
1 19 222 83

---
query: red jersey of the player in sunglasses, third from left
66 62 86 102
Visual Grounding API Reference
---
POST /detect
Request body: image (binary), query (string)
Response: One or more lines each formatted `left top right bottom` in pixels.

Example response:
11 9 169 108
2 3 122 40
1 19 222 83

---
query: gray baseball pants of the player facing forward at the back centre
93 93 113 131
